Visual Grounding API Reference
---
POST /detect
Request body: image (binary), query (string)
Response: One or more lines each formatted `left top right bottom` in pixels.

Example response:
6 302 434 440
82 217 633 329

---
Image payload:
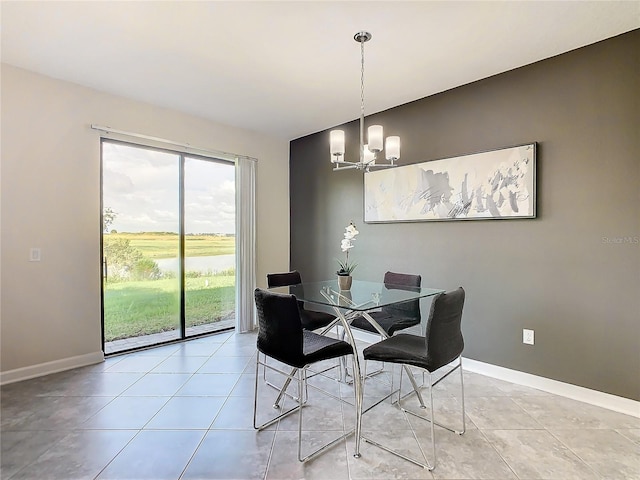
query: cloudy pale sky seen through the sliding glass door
102 142 235 234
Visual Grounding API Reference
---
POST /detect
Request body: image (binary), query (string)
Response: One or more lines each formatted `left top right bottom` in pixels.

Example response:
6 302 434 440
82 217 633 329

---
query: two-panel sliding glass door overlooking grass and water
102 140 235 353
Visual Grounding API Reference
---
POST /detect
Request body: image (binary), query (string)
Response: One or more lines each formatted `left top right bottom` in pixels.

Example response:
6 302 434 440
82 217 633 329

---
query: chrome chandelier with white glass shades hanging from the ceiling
329 31 400 172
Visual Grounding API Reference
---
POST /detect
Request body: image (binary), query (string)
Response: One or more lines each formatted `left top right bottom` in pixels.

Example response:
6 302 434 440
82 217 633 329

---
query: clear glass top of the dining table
270 279 444 311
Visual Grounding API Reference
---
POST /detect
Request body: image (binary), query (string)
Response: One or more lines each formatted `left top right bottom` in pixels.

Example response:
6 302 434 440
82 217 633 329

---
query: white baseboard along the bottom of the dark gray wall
353 329 640 418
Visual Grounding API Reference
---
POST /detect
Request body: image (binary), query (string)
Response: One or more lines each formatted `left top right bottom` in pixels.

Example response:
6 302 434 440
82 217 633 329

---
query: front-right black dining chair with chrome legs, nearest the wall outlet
362 287 466 470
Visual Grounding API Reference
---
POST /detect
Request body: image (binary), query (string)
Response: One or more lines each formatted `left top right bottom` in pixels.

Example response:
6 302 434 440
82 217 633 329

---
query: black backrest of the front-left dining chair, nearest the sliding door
254 288 304 365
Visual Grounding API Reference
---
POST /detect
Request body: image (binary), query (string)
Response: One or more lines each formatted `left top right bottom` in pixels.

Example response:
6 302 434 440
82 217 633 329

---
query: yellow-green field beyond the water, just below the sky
105 232 236 258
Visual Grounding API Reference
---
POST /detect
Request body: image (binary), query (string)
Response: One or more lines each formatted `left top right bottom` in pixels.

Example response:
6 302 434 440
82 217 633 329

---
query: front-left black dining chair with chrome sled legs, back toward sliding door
253 288 354 462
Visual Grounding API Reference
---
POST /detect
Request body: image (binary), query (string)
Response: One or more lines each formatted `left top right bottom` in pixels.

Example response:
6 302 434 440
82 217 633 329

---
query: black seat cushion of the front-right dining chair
362 333 458 372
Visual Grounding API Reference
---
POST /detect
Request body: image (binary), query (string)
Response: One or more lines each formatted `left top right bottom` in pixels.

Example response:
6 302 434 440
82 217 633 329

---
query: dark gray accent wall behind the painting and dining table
290 30 640 400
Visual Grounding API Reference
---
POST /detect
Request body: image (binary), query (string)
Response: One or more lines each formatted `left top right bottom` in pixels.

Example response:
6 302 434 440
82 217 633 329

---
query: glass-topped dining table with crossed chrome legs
270 280 444 458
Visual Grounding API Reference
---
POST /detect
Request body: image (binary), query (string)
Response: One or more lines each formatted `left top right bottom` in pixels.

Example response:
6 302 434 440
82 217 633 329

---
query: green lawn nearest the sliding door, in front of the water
104 275 235 342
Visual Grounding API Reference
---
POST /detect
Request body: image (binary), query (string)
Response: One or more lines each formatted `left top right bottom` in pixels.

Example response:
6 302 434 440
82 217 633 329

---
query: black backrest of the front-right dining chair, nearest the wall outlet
425 287 465 371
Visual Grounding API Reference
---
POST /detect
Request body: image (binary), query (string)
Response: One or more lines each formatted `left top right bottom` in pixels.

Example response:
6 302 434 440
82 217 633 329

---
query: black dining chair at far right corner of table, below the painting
351 272 422 337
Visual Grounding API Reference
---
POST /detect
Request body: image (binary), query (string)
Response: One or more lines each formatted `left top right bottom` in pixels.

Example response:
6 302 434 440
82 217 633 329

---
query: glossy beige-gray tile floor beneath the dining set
0 333 640 480
